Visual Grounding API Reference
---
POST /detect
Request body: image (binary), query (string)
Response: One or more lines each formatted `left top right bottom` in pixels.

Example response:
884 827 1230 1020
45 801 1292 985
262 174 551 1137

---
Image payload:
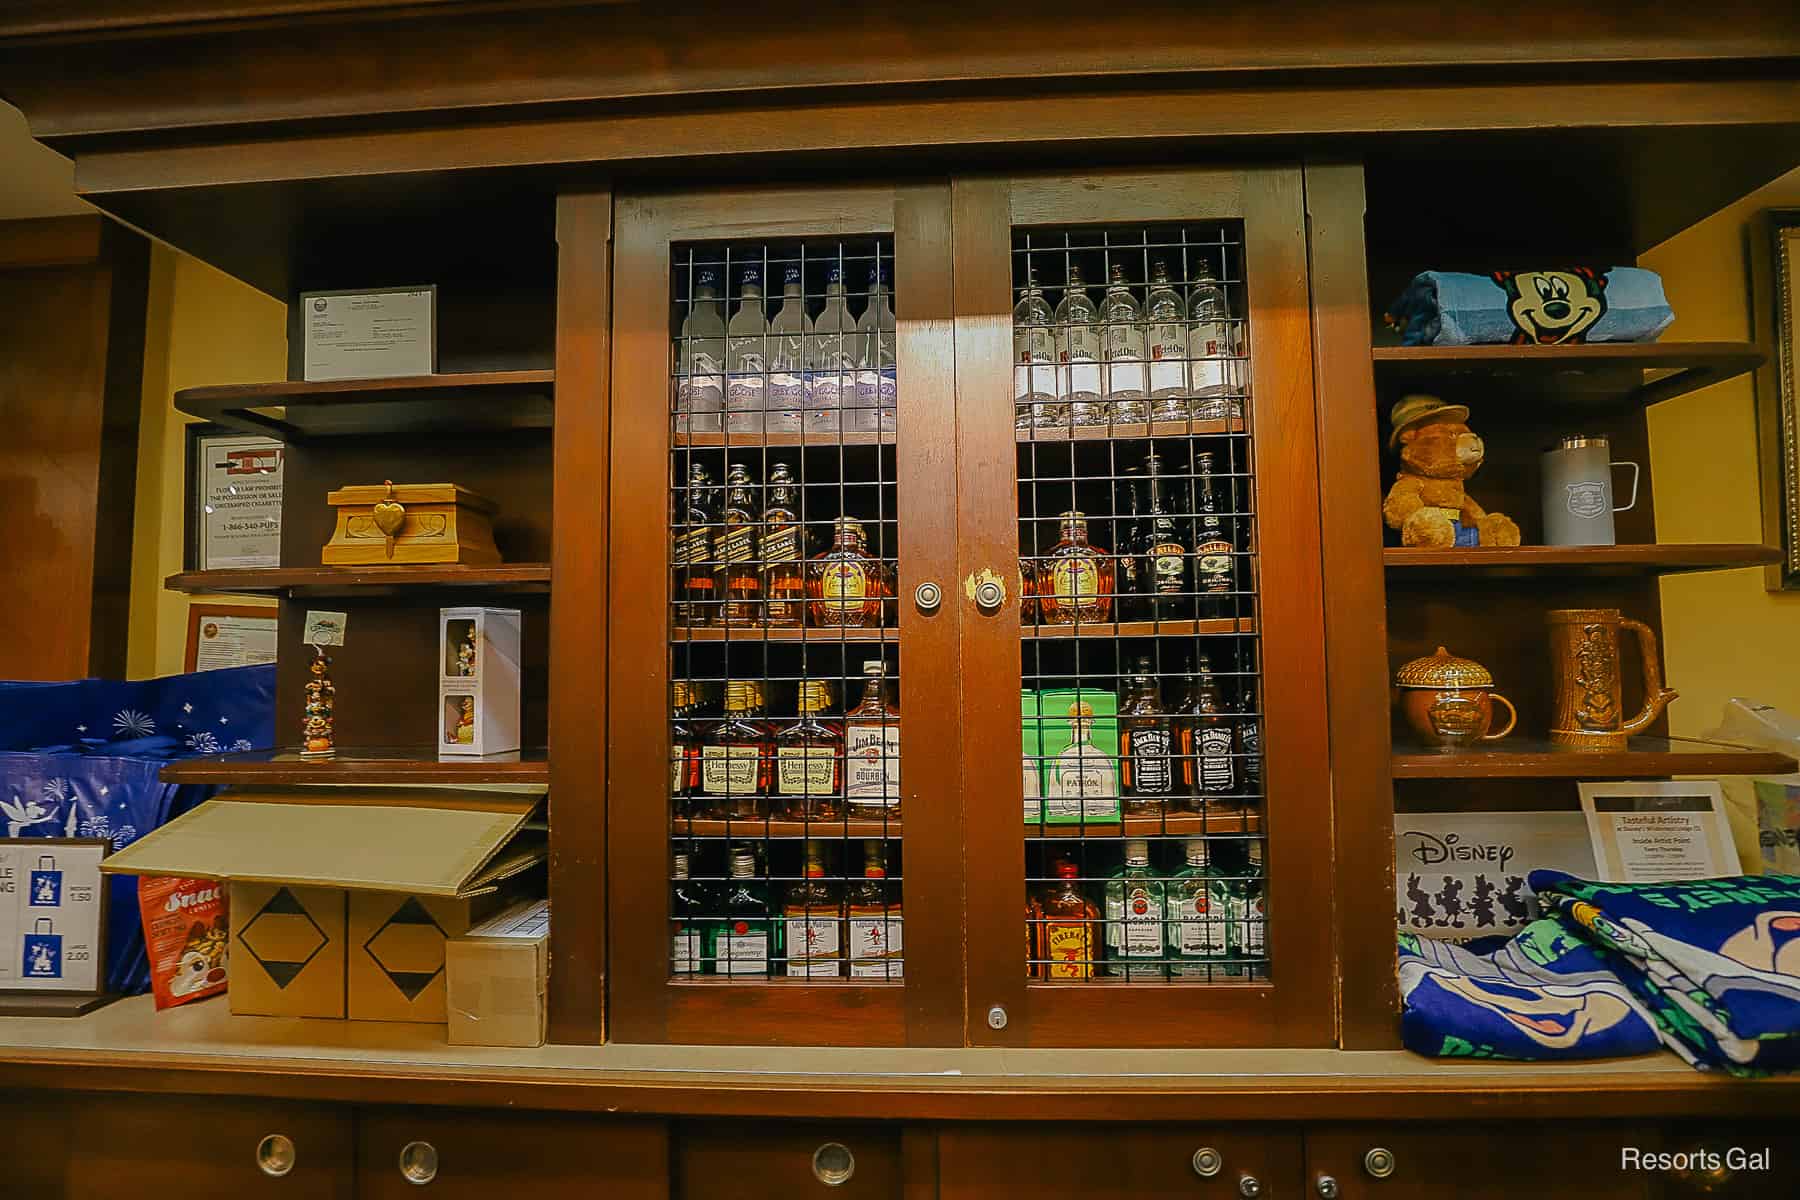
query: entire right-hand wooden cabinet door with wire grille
952 169 1334 1045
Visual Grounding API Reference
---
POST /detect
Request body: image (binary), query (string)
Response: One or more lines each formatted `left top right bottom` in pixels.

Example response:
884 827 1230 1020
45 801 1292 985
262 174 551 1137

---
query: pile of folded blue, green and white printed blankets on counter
1400 871 1800 1076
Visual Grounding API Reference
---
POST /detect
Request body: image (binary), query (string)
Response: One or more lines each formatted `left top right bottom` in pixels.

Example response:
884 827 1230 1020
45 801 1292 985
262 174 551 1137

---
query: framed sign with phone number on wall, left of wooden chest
185 425 286 570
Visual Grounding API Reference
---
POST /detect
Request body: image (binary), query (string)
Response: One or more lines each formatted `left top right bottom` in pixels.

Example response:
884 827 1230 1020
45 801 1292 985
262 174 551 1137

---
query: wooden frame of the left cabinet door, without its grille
607 182 965 1045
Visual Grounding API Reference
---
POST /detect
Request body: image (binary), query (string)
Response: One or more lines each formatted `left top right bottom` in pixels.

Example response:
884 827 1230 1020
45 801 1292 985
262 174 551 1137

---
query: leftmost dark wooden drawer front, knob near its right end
67 1096 355 1200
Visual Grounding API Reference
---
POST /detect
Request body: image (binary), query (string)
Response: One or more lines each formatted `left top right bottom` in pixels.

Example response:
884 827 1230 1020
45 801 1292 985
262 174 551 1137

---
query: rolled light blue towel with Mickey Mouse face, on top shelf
1386 266 1676 345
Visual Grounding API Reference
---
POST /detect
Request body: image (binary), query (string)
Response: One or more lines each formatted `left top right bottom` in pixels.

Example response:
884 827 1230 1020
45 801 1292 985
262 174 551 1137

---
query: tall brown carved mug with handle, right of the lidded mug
1544 608 1676 750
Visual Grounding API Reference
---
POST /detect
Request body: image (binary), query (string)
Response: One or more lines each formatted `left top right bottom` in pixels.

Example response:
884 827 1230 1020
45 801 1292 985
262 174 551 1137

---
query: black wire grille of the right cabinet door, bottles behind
1013 221 1269 982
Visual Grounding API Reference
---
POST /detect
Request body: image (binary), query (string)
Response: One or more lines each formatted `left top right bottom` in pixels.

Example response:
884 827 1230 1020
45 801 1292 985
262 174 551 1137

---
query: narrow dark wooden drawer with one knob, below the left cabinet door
673 1121 907 1200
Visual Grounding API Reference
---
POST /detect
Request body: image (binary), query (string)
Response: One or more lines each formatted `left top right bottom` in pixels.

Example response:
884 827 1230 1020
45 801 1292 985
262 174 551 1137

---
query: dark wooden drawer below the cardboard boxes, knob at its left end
356 1108 668 1200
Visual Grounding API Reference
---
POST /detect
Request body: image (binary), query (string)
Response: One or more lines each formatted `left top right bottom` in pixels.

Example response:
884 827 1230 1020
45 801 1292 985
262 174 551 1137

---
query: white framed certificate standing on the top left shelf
301 288 437 381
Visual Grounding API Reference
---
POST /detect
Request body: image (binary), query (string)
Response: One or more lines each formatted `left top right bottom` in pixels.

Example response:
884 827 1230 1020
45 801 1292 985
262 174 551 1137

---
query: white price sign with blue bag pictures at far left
0 838 106 991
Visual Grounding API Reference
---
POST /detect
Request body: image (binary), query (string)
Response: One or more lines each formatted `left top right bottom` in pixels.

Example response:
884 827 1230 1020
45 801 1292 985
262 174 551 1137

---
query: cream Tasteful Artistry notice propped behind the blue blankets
1580 781 1739 883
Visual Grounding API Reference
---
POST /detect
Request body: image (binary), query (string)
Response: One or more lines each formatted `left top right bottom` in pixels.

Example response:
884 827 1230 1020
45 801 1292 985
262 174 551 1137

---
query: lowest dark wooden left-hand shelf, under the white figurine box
162 747 551 786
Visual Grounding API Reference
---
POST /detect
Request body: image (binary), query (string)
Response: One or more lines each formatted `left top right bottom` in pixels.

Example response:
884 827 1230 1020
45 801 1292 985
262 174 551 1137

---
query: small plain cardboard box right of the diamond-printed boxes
445 900 551 1045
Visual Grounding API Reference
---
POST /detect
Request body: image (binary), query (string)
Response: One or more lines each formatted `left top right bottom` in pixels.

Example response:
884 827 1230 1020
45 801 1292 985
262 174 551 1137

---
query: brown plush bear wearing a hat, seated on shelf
1381 396 1519 547
